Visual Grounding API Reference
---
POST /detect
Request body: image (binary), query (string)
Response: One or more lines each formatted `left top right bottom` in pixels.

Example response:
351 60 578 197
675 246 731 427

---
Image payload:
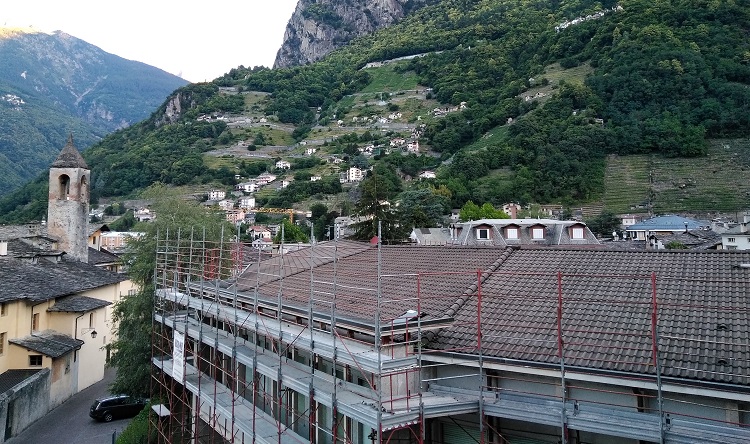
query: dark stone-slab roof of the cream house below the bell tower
0 256 128 302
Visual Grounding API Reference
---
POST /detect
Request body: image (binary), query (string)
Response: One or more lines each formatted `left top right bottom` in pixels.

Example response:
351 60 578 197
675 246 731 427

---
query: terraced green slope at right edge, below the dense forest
603 139 750 214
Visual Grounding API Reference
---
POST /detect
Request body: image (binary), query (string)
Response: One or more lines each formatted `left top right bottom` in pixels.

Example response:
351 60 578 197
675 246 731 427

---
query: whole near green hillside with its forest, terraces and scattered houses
0 0 750 225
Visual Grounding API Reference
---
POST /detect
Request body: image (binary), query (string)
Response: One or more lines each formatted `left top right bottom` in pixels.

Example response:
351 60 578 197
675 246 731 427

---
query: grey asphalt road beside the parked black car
6 368 130 444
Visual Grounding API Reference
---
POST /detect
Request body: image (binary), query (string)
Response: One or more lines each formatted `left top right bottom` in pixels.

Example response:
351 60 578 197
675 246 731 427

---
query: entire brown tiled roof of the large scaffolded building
231 242 750 385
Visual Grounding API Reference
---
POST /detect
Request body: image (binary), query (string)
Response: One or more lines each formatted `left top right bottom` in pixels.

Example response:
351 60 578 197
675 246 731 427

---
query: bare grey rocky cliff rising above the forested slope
274 0 439 68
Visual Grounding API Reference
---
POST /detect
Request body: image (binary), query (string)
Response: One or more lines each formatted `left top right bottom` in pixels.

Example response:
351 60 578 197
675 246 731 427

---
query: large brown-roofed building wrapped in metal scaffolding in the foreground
151 240 750 444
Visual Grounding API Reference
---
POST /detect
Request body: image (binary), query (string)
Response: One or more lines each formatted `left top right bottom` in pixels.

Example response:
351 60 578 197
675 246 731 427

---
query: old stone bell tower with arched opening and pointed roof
47 134 91 262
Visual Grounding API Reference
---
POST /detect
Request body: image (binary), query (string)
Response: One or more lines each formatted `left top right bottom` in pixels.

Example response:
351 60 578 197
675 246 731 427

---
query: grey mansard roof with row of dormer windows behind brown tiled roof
449 219 599 247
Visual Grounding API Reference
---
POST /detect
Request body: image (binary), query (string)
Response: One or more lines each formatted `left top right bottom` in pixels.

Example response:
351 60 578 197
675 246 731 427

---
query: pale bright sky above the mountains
0 0 297 82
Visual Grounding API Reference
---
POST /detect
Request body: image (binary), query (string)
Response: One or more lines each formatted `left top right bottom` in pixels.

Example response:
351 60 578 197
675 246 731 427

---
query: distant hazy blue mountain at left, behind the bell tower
0 28 187 195
